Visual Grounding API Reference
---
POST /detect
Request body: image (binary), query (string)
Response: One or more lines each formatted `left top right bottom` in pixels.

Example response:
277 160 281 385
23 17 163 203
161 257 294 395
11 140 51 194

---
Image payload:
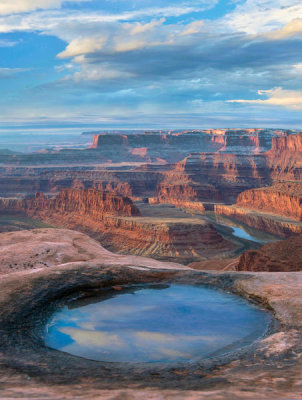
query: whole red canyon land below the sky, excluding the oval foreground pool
0 129 302 400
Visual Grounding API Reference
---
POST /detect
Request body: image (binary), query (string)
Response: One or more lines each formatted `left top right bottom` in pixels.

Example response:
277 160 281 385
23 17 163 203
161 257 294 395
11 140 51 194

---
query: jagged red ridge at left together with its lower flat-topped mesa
0 189 236 262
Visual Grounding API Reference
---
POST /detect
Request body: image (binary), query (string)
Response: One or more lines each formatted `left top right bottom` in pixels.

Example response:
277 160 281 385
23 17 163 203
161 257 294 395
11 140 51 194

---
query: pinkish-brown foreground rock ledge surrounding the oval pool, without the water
0 229 302 400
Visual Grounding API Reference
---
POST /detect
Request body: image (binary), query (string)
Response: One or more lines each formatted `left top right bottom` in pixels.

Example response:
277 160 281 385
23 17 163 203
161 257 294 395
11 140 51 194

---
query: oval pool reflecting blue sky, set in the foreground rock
45 284 270 362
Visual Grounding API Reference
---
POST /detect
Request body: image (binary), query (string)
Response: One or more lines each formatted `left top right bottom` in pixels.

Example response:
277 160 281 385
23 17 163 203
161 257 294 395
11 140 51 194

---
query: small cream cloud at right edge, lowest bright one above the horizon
228 87 302 110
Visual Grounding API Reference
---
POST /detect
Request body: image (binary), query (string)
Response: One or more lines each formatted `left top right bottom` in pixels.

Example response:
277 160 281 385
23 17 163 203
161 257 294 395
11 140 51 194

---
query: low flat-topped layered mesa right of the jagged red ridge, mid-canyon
99 217 236 263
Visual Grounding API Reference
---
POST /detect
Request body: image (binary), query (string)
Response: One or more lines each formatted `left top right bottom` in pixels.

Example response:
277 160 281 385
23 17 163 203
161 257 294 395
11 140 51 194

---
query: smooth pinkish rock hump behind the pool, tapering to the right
0 228 186 275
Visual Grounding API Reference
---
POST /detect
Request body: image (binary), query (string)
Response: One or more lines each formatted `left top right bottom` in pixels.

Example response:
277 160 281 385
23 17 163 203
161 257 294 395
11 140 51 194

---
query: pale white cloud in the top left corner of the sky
0 0 87 15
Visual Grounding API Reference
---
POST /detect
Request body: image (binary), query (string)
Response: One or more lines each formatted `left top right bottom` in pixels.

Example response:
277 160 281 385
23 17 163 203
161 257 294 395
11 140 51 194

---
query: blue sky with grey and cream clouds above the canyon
0 0 302 128
